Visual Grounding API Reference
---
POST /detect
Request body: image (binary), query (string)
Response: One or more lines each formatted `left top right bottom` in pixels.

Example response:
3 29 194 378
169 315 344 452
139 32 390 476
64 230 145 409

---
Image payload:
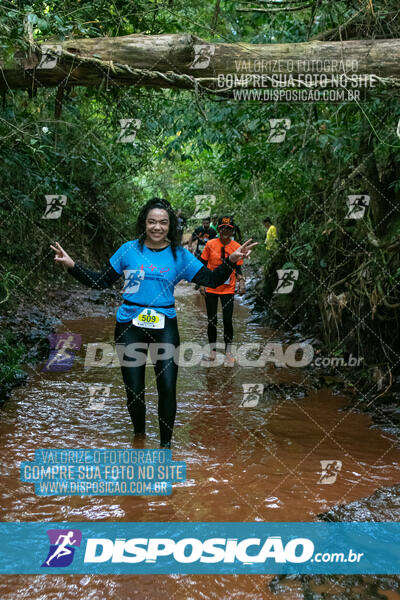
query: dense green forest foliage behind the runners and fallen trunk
0 0 400 392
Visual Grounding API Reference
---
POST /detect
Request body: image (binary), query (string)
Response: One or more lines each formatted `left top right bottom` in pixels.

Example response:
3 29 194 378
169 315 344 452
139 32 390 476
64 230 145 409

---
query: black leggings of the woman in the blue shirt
114 317 179 444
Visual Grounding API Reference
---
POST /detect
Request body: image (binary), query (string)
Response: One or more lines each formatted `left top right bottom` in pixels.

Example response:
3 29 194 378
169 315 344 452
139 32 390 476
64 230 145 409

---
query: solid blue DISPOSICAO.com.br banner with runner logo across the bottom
0 522 400 575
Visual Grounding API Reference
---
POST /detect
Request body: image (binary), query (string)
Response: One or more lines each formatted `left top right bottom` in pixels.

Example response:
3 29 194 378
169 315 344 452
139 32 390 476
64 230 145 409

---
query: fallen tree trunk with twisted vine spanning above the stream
0 34 400 93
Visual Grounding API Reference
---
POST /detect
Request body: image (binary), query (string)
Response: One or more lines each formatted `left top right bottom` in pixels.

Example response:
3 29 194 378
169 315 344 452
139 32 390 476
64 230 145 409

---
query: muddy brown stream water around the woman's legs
0 284 400 600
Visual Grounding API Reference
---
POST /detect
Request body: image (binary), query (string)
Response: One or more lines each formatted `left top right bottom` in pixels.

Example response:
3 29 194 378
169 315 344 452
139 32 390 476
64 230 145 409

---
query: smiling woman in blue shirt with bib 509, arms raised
50 198 255 448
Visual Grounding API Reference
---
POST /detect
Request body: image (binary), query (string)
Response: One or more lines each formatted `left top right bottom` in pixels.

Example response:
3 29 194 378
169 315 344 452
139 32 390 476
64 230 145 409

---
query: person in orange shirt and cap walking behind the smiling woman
200 216 245 364
